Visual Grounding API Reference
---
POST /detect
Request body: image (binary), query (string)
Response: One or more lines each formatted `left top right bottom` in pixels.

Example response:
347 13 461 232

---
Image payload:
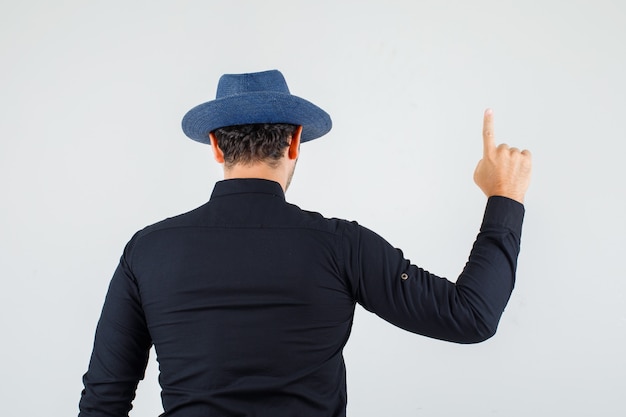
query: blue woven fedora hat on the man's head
182 70 332 143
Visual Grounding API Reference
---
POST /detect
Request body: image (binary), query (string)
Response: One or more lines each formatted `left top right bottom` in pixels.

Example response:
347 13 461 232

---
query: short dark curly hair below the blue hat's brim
213 123 298 167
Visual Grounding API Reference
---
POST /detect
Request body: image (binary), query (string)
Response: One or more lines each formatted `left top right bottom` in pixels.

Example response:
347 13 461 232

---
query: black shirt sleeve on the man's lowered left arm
79 237 152 417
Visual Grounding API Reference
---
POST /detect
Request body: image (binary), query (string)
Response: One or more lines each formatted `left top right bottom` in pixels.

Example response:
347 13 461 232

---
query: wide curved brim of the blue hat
182 91 332 143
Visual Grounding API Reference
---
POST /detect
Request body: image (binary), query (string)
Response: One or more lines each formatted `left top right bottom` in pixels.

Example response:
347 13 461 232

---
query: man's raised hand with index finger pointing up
474 109 532 204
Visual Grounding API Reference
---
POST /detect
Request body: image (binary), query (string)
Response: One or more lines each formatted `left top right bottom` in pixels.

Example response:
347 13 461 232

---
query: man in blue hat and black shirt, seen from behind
80 71 530 417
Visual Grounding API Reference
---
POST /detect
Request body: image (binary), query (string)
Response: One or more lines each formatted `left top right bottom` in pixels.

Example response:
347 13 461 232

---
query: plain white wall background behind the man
0 0 626 417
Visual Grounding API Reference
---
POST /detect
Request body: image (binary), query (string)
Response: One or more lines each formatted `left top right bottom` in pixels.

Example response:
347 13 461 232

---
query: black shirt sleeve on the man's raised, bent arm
344 197 524 343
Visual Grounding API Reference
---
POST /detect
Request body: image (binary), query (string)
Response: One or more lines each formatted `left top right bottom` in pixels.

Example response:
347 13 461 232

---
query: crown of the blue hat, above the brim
215 70 290 99
